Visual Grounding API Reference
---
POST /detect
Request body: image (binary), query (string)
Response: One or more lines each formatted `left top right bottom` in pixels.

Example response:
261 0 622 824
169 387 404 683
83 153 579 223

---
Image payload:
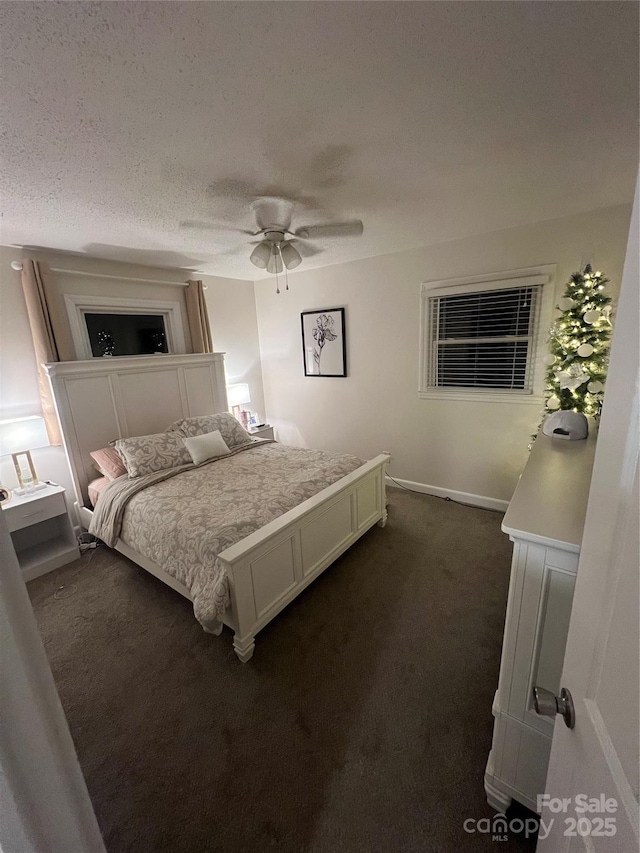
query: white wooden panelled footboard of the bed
219 454 389 662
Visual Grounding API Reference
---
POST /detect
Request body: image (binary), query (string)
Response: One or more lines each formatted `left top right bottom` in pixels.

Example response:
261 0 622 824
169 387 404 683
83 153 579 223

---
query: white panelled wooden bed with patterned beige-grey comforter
46 353 389 662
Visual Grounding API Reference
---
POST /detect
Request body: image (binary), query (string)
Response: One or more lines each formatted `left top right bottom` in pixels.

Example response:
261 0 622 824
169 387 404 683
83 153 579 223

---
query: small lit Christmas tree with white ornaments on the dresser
545 264 611 417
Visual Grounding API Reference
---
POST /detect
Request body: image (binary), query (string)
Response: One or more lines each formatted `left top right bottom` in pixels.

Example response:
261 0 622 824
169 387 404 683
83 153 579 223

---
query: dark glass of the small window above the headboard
84 313 169 358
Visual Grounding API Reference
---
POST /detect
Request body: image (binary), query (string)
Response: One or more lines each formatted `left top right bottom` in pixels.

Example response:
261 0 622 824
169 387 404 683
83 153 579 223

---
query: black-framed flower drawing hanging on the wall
300 308 347 378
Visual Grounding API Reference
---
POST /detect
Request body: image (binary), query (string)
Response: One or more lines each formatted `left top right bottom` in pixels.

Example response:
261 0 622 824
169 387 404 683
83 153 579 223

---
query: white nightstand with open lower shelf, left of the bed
2 486 80 581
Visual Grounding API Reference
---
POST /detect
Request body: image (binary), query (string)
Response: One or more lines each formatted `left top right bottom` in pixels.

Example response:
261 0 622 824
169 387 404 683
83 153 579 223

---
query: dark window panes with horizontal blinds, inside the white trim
426 284 542 394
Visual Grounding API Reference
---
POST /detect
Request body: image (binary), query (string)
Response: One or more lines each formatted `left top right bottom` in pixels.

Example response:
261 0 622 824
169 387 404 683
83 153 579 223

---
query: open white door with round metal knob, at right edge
537 176 640 853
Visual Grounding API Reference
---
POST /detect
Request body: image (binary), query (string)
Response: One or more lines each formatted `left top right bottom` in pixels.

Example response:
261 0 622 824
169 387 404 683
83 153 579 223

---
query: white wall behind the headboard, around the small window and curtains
0 246 264 501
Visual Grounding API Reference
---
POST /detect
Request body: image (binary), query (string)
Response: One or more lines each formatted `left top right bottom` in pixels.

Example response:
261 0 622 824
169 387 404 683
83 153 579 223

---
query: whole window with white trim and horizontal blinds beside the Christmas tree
420 271 549 399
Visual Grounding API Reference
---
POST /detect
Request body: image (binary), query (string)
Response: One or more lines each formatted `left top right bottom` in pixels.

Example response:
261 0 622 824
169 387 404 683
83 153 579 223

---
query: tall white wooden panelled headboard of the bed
44 353 228 506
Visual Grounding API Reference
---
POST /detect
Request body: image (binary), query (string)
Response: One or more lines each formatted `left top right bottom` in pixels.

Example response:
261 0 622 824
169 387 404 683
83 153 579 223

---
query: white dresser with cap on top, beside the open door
484 432 595 811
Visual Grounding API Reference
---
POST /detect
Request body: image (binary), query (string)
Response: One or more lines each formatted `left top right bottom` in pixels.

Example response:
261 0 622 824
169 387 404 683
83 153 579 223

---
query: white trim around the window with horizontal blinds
418 264 556 406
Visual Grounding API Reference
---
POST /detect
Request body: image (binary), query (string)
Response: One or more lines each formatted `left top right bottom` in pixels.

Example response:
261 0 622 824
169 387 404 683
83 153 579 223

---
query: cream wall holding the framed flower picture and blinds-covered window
254 205 631 502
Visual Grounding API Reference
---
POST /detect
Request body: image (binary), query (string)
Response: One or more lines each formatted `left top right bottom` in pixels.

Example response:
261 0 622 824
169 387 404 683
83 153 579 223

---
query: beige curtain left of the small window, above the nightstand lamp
22 259 62 445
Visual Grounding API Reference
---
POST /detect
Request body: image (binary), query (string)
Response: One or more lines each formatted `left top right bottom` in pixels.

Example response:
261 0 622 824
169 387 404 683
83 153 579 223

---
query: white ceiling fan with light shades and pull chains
180 196 364 275
